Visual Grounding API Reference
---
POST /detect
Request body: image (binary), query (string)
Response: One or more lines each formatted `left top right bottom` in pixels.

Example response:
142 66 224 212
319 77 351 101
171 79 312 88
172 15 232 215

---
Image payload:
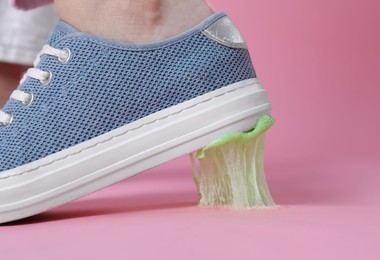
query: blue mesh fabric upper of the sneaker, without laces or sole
0 14 256 171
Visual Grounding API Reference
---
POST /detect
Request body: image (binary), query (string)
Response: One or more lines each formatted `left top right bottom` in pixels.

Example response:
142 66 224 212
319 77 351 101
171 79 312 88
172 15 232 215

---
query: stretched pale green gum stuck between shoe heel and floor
190 115 276 209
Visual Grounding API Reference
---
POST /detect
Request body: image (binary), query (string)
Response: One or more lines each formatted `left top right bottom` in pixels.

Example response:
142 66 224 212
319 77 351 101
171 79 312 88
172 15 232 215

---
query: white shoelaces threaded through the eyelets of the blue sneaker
0 45 70 126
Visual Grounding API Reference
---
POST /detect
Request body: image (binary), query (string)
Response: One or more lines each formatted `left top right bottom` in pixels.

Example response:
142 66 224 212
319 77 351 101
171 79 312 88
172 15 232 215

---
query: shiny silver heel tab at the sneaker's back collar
203 16 247 49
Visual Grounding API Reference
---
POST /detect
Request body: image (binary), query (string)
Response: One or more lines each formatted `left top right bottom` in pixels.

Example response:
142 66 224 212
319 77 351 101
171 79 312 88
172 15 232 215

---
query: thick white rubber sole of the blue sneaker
0 79 271 223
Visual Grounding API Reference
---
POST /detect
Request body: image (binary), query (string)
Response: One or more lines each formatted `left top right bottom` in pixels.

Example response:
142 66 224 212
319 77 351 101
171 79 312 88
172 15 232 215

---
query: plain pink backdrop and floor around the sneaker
0 0 380 260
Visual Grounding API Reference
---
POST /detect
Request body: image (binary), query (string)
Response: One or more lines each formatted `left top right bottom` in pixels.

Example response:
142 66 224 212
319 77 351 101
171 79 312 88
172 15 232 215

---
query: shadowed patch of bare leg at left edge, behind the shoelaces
0 62 26 108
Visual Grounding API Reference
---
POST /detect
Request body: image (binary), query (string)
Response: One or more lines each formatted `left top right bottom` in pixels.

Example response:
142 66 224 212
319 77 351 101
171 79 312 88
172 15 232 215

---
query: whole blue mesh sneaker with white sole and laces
0 13 271 223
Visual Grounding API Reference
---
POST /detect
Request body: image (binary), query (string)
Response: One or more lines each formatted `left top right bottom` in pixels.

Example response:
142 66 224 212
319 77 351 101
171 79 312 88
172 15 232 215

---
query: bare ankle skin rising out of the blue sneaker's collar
55 0 213 43
